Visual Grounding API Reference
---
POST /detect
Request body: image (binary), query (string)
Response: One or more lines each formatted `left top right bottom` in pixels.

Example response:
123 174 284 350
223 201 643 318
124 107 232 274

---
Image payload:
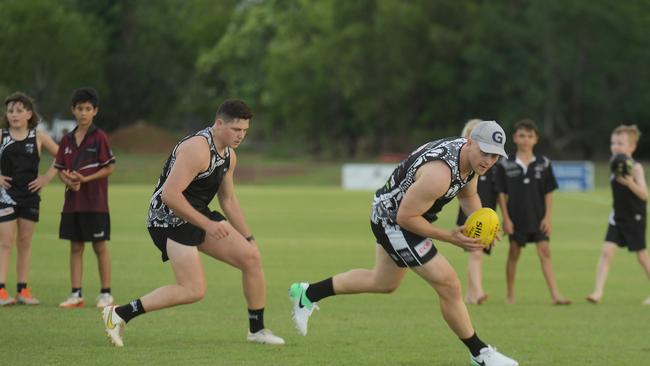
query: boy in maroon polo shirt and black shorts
55 88 115 308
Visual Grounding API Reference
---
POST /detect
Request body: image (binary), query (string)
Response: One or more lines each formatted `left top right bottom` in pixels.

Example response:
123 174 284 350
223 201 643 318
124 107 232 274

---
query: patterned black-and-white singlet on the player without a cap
147 127 230 228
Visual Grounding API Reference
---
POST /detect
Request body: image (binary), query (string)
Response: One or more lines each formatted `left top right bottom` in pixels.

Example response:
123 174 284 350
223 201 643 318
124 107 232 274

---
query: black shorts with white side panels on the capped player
370 221 438 267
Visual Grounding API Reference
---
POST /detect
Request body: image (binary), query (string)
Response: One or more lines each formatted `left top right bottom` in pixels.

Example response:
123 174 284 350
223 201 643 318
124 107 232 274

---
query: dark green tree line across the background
0 0 650 158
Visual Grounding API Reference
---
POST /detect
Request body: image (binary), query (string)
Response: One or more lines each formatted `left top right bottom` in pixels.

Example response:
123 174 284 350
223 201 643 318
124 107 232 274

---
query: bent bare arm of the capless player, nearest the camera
161 136 228 239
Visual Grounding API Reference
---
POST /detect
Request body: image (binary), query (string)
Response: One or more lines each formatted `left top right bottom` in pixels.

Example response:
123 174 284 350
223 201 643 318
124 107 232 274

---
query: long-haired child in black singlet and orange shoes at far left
0 92 58 306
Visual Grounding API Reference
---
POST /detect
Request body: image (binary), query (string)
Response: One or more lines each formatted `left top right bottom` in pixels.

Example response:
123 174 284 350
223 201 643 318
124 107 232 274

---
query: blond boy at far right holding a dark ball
587 125 650 305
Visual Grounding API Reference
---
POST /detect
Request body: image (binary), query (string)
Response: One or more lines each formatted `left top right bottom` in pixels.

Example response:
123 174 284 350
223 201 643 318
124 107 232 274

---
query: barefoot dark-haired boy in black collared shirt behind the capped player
497 119 571 305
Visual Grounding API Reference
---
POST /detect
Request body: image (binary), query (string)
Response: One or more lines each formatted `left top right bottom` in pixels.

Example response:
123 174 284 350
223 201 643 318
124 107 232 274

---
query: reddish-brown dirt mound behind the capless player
109 122 182 154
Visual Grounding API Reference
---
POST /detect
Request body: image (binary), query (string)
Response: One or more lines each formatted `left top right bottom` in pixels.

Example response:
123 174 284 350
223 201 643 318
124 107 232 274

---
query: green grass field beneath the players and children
0 173 650 366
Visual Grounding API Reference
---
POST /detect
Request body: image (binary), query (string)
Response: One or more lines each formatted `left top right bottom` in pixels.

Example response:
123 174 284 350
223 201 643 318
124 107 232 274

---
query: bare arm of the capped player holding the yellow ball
397 161 482 250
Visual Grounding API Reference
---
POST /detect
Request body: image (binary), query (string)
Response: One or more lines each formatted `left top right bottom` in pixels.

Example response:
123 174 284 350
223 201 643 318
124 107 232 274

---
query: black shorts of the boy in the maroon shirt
59 212 111 243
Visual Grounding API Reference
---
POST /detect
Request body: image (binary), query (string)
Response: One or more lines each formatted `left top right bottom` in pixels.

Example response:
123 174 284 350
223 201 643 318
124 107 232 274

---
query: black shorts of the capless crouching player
147 211 226 262
